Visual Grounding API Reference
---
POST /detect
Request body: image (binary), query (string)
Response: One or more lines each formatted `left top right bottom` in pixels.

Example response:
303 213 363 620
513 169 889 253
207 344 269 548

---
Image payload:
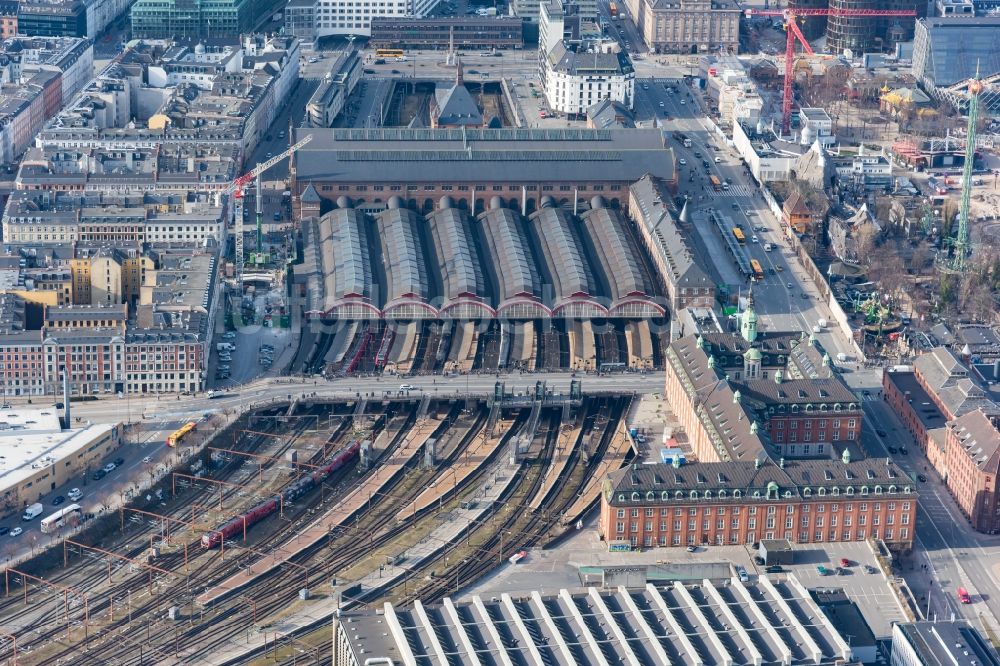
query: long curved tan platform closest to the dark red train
197 419 442 606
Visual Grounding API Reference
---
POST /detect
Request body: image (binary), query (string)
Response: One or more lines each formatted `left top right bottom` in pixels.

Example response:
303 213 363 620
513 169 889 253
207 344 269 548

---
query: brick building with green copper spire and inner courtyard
664 293 863 462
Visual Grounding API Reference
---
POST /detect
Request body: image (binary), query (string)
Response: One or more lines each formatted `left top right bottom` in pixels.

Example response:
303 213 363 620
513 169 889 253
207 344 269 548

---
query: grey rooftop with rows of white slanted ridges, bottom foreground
335 576 851 666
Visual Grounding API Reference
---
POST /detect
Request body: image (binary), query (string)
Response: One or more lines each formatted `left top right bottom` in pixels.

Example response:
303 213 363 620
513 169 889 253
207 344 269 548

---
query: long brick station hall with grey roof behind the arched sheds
292 128 677 217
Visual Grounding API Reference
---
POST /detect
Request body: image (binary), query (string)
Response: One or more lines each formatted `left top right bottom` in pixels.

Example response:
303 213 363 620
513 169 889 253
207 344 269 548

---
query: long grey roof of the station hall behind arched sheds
295 128 674 184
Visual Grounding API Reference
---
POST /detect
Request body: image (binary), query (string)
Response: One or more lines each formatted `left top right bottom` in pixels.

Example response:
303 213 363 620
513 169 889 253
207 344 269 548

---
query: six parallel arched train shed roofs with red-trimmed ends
298 192 666 321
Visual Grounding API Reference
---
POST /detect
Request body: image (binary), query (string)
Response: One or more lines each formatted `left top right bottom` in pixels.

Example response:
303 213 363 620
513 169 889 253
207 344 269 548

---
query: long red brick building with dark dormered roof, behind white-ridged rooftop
598 452 917 551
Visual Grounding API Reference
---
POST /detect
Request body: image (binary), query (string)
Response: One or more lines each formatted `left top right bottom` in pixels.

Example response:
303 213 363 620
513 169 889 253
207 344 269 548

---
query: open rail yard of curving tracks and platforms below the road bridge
0 395 631 664
